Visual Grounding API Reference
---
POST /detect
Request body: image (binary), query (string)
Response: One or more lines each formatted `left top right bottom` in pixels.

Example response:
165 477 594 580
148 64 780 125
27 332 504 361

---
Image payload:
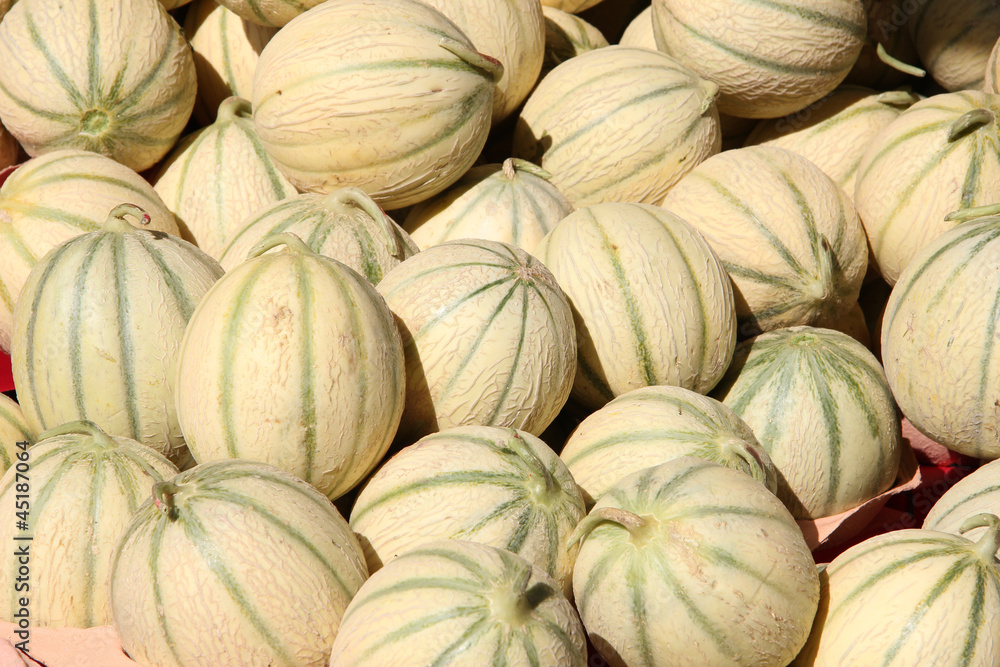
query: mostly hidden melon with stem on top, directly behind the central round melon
403 158 573 253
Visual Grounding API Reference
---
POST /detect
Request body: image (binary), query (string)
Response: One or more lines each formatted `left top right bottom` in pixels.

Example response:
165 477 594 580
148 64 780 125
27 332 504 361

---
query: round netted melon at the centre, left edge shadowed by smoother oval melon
378 239 577 444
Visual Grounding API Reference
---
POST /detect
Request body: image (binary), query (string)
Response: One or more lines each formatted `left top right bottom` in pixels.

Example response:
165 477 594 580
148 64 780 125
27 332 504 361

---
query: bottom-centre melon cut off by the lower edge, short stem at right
330 540 592 667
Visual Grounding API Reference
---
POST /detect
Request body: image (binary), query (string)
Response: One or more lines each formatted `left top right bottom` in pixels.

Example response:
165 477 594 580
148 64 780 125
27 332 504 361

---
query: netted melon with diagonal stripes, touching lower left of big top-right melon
513 46 721 206
